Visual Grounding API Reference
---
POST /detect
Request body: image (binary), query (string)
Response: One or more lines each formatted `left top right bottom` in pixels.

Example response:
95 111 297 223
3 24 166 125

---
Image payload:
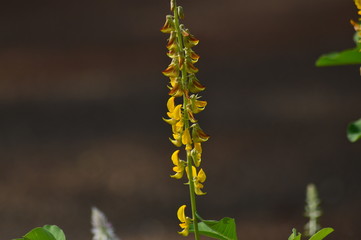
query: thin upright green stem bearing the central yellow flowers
171 0 199 240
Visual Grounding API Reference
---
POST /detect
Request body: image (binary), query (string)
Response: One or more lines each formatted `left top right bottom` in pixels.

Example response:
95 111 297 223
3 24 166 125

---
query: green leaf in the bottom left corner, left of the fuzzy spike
15 225 66 240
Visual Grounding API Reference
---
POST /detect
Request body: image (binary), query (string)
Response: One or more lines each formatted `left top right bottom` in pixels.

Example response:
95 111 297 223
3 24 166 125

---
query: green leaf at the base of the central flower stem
189 217 238 240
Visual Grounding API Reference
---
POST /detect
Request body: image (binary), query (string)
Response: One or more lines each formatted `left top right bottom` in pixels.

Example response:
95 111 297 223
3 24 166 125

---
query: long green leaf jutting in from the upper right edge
316 47 361 67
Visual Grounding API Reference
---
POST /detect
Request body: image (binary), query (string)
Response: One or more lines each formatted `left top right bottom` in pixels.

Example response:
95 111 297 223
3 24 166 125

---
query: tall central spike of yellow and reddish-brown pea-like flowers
161 0 209 235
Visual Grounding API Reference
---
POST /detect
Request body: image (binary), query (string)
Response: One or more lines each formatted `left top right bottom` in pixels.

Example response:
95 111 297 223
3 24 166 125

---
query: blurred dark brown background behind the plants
0 0 361 240
